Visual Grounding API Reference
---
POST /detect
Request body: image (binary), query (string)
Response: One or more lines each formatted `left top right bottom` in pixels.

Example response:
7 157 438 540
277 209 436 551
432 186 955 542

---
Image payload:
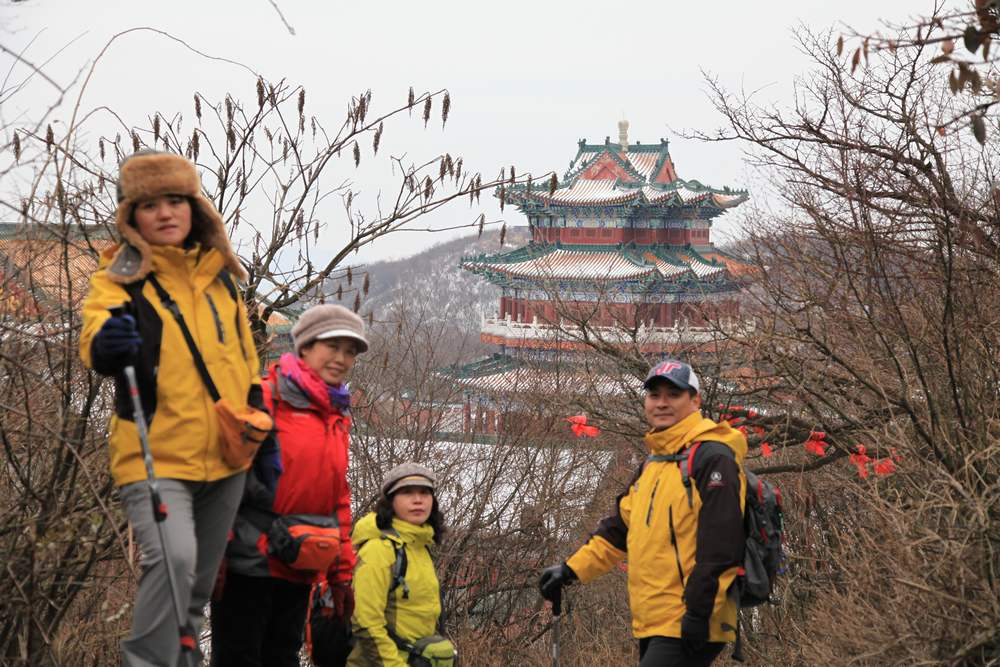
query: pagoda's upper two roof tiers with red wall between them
462 129 747 294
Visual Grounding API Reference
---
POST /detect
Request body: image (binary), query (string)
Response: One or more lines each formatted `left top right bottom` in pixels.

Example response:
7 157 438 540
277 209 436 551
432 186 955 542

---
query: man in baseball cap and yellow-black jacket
539 359 747 667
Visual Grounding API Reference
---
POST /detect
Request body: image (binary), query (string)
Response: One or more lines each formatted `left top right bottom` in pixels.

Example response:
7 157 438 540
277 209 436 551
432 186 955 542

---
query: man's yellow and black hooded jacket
566 412 747 642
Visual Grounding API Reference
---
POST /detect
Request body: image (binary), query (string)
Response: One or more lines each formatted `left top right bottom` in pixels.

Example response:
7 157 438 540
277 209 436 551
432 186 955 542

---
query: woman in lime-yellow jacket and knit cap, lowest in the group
347 463 454 667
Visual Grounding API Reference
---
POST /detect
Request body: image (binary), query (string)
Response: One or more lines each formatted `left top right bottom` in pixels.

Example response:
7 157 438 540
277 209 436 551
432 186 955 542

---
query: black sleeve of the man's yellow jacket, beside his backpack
684 442 746 618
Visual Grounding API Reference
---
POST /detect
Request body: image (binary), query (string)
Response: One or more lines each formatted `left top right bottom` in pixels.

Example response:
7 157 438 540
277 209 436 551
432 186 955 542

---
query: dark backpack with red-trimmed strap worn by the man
647 442 784 608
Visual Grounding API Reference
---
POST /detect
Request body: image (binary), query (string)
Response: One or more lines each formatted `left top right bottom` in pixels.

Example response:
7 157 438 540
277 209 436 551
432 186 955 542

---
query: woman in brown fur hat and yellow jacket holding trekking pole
80 151 262 667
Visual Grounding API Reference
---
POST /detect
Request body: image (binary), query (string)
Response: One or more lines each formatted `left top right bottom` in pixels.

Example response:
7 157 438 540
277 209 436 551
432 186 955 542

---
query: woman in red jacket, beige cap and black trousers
212 305 368 667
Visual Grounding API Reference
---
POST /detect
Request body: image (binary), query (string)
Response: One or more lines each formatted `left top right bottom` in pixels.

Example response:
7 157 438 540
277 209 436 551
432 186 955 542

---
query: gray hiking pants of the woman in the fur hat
121 473 246 667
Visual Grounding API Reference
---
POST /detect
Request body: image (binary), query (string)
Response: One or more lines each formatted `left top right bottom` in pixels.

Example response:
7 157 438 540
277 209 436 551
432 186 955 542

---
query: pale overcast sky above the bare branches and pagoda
0 0 931 261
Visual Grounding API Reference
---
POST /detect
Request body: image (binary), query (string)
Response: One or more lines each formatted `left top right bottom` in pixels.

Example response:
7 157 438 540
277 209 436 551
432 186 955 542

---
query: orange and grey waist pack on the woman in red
267 514 340 572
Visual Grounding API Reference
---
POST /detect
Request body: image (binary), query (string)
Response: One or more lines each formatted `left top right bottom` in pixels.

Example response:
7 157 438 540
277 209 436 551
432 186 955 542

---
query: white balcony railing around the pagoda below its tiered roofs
481 315 754 343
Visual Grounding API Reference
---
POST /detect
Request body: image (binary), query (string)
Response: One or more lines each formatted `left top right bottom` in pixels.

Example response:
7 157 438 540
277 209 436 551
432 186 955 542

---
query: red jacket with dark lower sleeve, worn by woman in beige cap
226 354 355 583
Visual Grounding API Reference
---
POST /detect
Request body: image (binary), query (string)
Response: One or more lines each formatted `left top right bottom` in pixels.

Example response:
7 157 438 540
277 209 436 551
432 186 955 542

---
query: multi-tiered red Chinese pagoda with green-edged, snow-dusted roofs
452 121 748 426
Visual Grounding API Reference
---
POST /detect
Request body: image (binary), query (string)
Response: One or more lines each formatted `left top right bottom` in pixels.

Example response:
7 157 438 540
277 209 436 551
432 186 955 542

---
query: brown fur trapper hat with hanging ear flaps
108 150 247 284
